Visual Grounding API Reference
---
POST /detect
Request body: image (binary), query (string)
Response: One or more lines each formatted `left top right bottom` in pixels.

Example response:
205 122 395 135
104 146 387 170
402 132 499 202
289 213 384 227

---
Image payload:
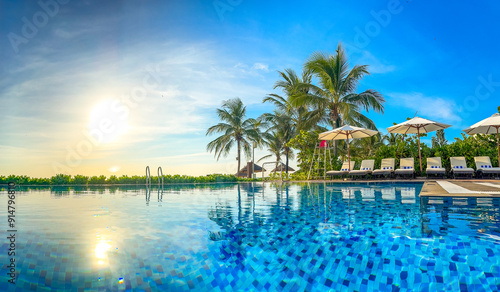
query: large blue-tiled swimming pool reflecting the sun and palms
0 182 500 291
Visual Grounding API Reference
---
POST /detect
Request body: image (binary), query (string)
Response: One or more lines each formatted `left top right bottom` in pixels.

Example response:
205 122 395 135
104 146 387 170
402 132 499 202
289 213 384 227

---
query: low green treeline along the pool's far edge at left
0 174 258 185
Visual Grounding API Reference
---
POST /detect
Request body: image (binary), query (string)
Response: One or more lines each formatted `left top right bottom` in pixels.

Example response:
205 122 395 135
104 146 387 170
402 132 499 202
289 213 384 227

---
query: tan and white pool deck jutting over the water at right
420 180 500 198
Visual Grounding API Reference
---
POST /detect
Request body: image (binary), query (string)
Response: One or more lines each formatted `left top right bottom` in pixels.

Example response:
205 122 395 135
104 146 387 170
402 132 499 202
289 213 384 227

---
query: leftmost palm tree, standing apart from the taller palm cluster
206 98 260 176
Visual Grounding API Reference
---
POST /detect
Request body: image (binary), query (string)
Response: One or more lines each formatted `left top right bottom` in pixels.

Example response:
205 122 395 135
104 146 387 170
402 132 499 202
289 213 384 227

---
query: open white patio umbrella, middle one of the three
387 117 451 172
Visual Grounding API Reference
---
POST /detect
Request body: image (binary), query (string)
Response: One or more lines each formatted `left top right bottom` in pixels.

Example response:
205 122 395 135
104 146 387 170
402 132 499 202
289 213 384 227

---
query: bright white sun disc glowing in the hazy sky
88 99 128 143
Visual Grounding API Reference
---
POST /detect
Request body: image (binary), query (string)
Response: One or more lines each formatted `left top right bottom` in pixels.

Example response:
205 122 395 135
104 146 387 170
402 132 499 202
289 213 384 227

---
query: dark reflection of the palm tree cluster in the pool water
204 185 348 276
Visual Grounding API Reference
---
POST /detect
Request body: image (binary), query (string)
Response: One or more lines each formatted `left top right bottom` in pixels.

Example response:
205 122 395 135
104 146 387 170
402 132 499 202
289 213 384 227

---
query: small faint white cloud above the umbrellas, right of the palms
387 92 462 123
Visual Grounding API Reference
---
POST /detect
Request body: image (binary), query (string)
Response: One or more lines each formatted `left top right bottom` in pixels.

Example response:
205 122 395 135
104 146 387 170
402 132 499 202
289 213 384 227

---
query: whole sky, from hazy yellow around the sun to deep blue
0 0 500 177
